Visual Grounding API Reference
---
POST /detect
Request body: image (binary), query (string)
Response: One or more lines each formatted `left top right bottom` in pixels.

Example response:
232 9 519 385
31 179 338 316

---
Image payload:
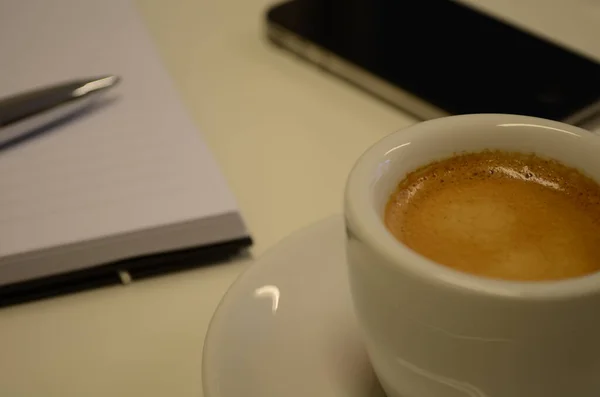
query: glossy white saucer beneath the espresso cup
202 216 384 397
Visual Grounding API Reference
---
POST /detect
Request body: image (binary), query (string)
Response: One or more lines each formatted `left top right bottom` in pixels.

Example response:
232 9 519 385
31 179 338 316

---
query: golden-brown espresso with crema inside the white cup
384 151 600 281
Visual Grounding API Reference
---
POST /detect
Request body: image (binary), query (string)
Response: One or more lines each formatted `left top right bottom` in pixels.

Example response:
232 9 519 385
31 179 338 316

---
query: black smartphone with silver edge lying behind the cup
266 0 600 124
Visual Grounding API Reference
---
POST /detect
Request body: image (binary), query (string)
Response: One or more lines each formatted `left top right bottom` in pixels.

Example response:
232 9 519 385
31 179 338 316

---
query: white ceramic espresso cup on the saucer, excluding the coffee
345 114 600 397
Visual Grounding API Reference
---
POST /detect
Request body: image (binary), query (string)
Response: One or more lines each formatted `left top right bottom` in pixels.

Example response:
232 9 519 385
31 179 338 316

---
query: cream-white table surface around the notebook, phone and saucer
0 0 600 397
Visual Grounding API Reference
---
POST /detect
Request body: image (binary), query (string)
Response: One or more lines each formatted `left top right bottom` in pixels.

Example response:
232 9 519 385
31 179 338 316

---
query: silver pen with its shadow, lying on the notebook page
0 76 120 147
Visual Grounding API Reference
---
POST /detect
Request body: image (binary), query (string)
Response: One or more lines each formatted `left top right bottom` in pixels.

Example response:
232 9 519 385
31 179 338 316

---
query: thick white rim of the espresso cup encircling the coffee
344 114 600 300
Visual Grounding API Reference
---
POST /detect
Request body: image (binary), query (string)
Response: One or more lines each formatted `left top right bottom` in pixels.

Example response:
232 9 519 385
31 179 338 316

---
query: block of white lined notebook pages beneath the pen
0 0 250 295
